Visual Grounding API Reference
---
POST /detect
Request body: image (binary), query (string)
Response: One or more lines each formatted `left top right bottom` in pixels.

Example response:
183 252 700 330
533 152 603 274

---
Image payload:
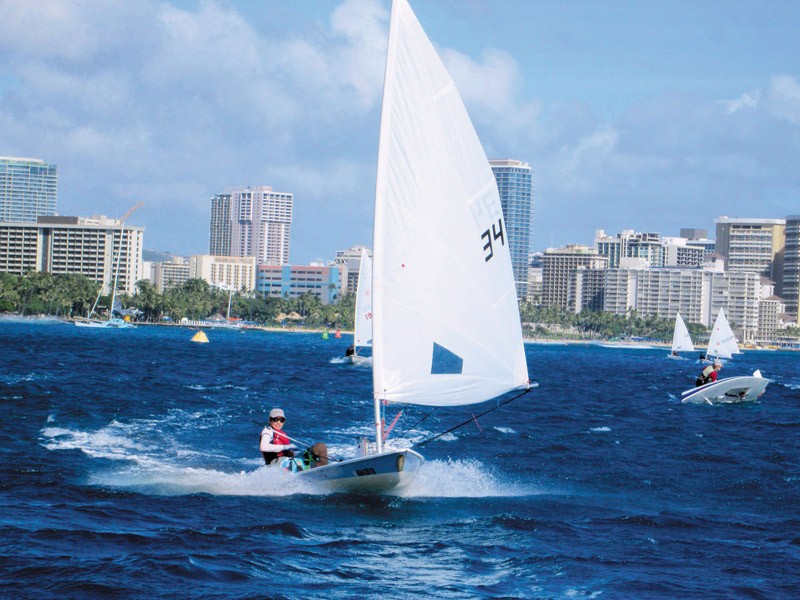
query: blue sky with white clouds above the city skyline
0 0 800 264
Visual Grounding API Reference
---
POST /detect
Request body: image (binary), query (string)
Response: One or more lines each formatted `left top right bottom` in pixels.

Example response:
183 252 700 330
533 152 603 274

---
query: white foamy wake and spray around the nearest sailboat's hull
40 411 542 498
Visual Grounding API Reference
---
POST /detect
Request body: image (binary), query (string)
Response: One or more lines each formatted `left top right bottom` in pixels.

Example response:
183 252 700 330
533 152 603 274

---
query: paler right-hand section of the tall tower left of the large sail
228 186 294 265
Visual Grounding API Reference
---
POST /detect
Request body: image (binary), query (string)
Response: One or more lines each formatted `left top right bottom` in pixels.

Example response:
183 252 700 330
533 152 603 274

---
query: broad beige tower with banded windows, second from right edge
714 217 786 288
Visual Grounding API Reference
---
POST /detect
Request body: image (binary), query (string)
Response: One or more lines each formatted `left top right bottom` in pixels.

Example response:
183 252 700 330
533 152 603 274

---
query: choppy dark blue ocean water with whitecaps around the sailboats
0 322 800 599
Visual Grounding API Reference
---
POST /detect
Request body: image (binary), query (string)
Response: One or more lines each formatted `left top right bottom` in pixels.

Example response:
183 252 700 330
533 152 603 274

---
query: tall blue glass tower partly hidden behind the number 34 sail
489 159 533 299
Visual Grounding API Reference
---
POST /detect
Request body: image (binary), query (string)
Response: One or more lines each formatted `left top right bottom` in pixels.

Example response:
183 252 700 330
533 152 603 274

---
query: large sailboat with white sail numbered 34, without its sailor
290 0 530 493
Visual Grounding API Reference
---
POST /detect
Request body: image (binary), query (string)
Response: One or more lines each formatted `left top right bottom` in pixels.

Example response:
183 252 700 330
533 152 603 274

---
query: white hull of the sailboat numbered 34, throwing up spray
297 450 418 493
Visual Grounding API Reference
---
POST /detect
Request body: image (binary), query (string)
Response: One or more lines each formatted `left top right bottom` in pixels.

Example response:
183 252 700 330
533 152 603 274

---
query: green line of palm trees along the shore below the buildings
0 272 800 341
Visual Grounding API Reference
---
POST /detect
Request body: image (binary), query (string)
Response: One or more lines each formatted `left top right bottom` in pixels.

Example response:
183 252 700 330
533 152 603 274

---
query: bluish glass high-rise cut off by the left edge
0 156 58 223
